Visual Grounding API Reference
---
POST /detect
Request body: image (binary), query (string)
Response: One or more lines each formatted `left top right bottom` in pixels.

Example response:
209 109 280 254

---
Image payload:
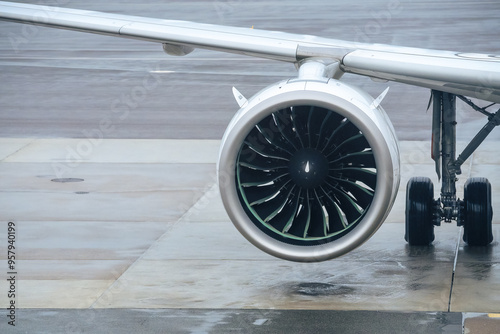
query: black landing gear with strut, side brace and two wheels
405 91 500 246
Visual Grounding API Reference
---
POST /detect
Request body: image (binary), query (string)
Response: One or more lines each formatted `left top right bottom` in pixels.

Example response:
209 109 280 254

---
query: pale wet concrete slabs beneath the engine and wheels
0 138 500 332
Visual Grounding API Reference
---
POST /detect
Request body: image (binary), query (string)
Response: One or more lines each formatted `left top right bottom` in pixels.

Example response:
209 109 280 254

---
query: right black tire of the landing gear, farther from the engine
463 177 493 246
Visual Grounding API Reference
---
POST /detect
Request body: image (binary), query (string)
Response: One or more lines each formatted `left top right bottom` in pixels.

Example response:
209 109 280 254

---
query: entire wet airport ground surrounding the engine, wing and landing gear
0 1 500 334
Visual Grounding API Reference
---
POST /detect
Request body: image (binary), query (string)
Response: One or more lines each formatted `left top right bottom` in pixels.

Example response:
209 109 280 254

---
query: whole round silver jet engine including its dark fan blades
217 79 400 262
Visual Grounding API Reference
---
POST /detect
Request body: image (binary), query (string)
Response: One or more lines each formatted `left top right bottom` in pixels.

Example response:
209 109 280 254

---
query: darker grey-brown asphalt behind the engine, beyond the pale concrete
0 0 500 140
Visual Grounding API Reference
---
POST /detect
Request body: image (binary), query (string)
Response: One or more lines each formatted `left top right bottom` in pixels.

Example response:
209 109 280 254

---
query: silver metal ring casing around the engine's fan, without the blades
218 81 399 262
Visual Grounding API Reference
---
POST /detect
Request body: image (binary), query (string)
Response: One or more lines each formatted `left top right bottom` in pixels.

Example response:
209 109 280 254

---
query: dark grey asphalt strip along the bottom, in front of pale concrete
0 309 462 334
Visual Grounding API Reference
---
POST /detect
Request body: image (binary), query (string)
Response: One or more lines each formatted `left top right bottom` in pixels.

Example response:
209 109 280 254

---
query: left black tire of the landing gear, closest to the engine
405 177 434 246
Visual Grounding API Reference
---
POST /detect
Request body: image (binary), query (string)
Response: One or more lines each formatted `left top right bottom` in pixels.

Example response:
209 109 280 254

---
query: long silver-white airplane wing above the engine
0 1 500 103
